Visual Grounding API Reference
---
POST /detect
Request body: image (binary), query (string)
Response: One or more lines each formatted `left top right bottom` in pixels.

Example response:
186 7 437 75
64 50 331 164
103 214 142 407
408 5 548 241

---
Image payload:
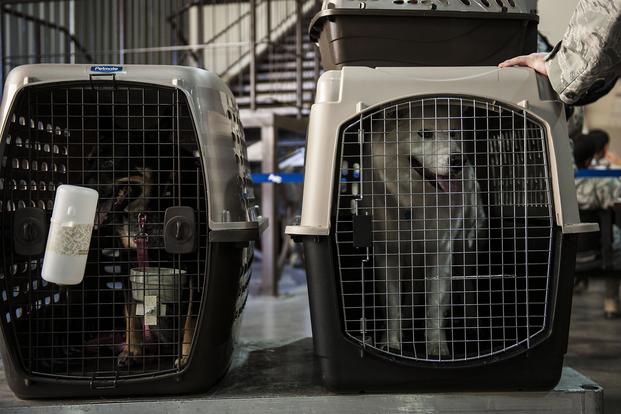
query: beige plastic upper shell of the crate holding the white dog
286 67 593 236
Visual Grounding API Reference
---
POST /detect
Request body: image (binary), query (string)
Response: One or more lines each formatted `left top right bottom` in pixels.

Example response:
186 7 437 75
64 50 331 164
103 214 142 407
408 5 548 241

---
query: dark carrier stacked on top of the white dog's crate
310 0 539 69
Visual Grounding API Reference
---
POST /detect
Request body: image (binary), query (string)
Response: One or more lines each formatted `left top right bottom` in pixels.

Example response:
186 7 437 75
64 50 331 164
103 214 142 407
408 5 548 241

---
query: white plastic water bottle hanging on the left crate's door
41 185 99 285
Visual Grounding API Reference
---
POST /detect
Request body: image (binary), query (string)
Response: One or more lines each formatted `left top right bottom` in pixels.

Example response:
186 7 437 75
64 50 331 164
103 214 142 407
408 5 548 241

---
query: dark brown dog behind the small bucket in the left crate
87 142 198 369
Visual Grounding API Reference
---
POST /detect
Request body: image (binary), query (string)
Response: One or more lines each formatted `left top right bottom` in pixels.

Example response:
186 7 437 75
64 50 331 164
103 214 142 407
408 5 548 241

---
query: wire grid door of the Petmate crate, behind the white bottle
0 81 208 378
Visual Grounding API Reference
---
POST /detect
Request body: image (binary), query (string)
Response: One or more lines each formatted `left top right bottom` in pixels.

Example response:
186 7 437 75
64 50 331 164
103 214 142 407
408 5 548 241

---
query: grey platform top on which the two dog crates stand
0 338 604 414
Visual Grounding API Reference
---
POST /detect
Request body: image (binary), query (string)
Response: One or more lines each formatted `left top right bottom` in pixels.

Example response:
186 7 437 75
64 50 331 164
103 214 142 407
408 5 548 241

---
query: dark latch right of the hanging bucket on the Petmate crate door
164 206 196 254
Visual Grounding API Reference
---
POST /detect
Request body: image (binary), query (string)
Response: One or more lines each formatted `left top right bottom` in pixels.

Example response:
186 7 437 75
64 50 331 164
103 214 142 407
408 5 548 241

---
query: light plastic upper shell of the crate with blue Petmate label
0 64 267 241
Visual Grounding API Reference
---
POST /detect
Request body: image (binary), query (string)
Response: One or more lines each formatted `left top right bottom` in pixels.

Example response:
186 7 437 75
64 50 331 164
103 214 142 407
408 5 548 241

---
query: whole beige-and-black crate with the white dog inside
287 67 590 391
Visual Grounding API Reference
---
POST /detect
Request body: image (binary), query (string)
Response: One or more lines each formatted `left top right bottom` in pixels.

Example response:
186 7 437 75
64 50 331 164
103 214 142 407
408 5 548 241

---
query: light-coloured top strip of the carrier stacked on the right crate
312 0 537 14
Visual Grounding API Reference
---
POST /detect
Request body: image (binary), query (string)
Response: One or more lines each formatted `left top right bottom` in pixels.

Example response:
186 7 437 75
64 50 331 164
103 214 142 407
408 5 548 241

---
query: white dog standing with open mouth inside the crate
360 105 485 358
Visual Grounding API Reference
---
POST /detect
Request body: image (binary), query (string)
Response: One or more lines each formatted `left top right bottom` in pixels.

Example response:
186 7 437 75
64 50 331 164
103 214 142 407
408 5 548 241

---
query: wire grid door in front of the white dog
334 96 554 363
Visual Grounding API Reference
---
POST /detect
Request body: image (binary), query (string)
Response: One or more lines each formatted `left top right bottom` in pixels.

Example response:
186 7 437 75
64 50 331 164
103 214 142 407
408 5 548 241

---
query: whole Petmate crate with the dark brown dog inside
0 65 262 398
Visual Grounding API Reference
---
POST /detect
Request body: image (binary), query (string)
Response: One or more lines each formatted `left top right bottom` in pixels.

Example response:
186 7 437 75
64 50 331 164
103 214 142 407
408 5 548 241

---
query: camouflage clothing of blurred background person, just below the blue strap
576 178 621 210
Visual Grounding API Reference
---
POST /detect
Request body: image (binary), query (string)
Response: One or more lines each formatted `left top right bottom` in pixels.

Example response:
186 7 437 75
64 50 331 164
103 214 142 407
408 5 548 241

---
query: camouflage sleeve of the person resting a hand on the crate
546 0 621 104
